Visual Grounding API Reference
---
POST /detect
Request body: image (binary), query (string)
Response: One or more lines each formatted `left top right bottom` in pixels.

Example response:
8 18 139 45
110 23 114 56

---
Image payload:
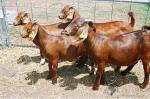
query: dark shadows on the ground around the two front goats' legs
25 65 139 94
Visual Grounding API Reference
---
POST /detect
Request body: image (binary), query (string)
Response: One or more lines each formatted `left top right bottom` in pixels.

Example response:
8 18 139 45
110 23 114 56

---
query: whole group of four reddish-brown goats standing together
13 5 150 90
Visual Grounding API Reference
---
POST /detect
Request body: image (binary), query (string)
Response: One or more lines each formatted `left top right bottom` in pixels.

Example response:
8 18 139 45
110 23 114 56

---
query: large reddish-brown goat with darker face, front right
64 18 150 90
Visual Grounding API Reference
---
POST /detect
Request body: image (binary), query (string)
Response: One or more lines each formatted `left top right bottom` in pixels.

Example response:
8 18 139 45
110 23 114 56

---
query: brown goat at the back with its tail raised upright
59 5 135 35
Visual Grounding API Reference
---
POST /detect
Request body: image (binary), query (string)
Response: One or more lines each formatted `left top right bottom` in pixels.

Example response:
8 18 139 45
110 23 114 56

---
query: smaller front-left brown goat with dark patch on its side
21 22 85 84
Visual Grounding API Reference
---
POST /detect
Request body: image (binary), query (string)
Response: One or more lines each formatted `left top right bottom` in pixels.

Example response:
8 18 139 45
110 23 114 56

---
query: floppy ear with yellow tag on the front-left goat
29 23 39 40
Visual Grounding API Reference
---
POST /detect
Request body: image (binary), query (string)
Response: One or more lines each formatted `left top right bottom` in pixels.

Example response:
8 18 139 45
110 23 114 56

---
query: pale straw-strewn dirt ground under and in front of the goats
0 38 150 99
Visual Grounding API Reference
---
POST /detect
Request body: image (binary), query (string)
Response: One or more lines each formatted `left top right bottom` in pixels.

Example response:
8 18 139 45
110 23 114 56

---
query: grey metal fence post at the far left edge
0 0 10 47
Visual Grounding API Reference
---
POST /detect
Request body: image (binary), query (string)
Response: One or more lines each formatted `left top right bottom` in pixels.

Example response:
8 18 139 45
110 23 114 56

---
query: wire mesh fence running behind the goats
2 0 150 47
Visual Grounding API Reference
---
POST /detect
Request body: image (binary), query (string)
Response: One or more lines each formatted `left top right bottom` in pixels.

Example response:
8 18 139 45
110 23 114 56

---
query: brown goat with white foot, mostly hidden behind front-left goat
13 11 86 66
